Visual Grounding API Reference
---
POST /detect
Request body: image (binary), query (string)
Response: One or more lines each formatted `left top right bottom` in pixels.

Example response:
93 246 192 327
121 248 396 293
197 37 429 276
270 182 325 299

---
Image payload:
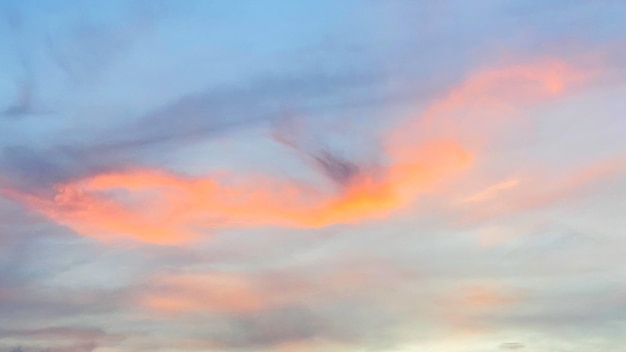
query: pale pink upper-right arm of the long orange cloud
388 59 593 151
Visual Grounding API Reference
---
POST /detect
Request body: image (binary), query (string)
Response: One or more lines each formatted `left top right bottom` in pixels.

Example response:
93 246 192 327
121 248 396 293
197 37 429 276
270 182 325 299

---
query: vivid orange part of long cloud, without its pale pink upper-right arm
0 142 469 243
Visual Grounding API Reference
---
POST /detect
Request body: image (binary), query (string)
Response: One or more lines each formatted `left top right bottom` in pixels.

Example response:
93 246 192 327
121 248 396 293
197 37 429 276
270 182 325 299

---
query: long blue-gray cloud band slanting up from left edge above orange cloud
0 66 376 191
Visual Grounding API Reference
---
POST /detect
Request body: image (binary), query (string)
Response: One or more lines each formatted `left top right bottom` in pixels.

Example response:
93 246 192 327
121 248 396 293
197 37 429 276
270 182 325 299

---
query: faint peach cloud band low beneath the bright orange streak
134 258 416 315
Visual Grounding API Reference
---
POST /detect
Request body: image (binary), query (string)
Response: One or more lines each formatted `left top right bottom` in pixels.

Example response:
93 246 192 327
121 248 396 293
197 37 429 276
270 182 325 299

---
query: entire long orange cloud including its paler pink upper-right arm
4 60 584 243
